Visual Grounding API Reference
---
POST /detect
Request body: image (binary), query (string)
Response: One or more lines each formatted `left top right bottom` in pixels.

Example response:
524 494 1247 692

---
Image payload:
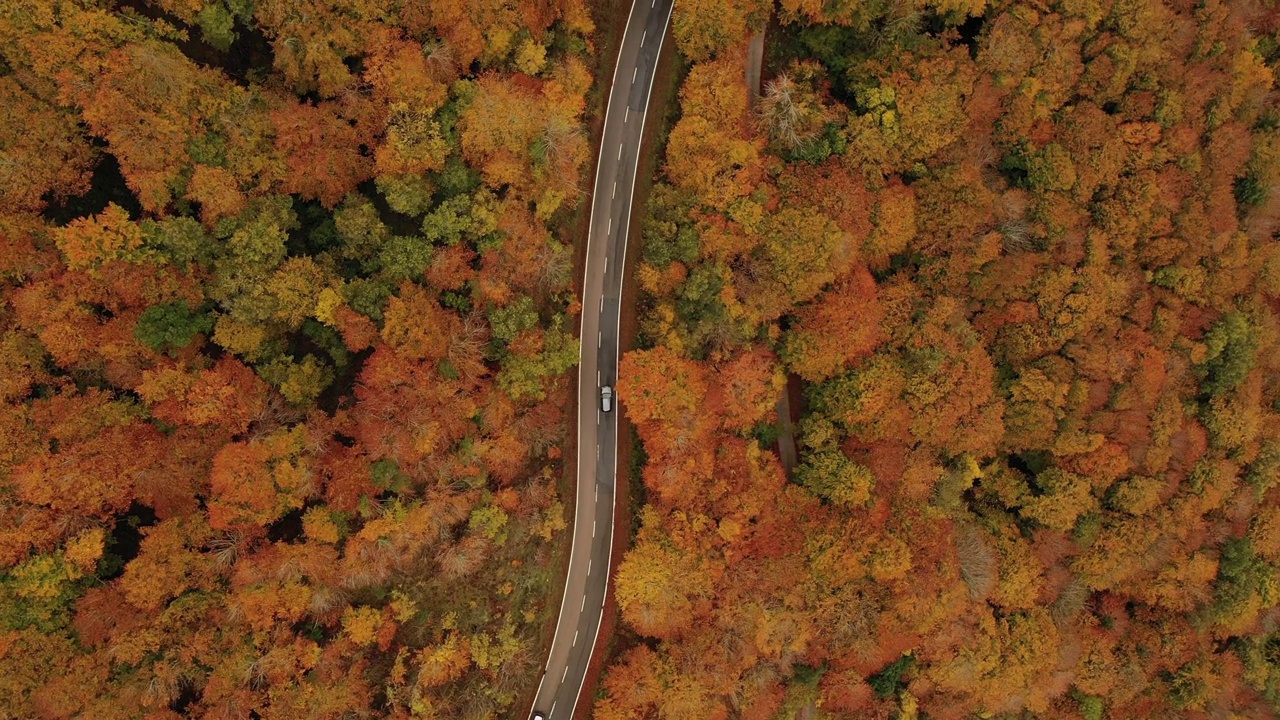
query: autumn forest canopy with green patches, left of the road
0 0 596 720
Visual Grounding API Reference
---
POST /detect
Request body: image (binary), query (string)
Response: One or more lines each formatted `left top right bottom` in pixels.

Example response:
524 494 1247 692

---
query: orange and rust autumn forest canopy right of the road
595 0 1280 720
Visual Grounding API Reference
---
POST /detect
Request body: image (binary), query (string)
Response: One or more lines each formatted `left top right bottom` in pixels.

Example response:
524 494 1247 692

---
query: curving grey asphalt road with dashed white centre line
531 0 673 720
